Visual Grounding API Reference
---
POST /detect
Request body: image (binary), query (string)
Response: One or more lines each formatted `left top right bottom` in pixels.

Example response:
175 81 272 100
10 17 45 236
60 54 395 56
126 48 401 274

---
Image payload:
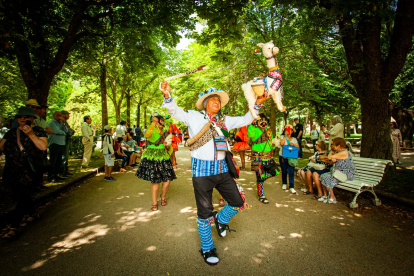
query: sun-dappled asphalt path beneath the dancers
0 148 414 276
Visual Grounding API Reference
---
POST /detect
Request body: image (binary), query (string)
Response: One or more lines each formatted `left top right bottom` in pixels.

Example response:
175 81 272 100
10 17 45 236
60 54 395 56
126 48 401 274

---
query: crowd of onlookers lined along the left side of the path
0 99 147 240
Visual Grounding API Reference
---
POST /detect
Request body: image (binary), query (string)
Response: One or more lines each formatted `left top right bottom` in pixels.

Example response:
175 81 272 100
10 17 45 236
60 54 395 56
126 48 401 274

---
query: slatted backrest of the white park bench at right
352 157 393 186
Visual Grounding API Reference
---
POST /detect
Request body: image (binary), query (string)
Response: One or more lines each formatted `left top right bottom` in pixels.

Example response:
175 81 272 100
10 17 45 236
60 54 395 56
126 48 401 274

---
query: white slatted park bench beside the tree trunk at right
335 157 393 208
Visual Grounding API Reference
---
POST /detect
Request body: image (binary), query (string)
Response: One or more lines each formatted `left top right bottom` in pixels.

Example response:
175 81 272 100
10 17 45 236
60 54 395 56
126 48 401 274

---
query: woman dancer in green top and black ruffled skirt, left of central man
136 115 177 211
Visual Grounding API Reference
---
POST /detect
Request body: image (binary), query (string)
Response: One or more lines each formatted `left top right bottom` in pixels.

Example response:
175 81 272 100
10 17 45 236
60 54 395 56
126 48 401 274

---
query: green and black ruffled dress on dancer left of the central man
136 127 177 183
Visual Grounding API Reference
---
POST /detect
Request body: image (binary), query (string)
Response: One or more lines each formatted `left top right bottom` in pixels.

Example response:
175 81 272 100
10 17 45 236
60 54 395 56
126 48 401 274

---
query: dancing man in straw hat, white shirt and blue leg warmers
161 81 269 265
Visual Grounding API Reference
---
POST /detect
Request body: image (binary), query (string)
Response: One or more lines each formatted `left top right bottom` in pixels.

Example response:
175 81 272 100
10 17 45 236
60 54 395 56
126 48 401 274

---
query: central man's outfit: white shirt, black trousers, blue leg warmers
162 91 261 252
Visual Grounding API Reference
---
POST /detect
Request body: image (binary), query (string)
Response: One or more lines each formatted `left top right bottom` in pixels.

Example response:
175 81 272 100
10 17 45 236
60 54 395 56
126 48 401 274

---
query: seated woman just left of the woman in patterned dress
298 141 331 195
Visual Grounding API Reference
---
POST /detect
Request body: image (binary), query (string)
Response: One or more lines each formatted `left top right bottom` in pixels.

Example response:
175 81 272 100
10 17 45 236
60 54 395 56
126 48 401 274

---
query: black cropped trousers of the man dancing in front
193 172 244 219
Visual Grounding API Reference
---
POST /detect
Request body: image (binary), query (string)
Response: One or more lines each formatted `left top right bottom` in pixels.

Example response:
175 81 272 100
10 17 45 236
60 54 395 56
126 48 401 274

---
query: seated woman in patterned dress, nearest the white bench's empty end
318 137 355 203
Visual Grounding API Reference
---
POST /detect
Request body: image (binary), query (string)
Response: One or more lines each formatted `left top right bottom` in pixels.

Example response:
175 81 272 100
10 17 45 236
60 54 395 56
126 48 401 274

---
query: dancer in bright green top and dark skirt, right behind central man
247 113 280 204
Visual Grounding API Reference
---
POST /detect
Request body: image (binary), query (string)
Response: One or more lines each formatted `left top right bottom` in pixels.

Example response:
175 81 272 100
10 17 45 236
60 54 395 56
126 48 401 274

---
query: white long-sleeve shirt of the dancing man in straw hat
162 98 260 160
